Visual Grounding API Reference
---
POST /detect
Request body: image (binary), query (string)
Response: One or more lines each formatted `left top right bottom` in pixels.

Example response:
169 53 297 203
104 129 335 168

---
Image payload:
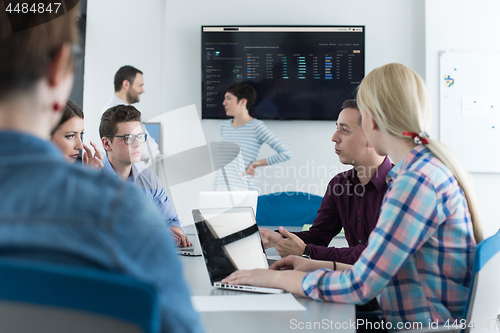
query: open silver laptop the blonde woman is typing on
192 207 285 294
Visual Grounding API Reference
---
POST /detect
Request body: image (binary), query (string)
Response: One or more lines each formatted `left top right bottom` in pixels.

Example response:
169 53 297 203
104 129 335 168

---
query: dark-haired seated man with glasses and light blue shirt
99 105 192 247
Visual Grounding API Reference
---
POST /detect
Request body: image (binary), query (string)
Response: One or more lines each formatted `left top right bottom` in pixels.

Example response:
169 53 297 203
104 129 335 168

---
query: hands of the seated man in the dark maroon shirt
259 227 306 258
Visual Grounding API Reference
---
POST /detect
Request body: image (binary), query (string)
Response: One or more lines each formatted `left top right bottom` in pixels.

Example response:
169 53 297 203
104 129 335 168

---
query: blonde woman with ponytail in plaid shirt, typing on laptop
223 64 482 330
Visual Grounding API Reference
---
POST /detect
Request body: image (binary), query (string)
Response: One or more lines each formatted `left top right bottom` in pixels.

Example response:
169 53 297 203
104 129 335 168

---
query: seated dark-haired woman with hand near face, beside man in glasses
51 100 103 169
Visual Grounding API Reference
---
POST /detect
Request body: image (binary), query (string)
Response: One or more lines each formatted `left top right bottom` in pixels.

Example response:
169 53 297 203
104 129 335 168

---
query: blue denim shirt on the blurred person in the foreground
0 131 203 332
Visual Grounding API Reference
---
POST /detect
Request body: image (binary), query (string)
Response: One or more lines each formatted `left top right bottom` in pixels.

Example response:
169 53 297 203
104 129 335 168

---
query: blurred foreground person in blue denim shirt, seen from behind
0 5 203 332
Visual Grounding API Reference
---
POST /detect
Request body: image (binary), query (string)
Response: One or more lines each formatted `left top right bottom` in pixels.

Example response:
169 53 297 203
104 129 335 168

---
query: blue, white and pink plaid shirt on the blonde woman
302 145 476 329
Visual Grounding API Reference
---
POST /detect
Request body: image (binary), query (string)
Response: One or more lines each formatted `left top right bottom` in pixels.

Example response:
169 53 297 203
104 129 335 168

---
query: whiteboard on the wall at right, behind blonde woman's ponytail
439 51 500 173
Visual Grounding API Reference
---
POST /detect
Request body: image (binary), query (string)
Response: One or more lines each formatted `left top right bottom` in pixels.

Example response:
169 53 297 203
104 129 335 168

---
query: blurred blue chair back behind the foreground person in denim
0 259 161 333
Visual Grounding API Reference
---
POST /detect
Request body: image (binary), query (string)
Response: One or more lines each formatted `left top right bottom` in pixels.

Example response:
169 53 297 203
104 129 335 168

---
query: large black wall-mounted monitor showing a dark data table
201 26 365 120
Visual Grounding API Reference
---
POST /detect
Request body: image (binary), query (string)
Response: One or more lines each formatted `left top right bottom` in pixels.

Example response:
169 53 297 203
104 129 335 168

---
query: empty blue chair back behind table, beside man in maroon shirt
256 192 323 227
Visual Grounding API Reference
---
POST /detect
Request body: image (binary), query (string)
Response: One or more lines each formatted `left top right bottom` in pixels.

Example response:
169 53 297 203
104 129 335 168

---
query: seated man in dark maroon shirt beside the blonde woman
259 99 392 264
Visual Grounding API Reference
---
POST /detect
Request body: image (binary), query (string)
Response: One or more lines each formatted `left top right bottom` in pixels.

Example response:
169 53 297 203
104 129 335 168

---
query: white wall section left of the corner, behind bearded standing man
83 0 165 142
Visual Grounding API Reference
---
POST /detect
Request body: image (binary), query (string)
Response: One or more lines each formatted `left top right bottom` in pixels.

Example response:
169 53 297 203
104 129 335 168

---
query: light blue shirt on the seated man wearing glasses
102 156 186 233
